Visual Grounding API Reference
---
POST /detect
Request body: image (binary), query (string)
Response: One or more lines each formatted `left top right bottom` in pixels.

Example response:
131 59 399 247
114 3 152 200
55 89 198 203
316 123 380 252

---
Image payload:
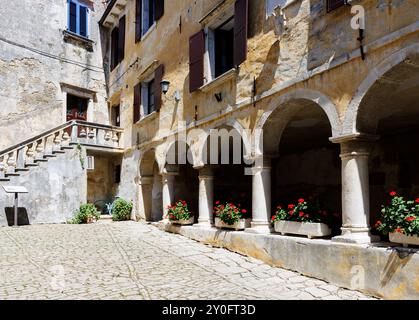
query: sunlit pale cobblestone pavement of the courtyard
0 222 376 300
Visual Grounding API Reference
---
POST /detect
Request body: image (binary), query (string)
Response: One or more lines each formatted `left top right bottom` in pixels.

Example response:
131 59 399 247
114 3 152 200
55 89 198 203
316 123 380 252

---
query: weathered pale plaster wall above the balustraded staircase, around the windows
0 0 108 150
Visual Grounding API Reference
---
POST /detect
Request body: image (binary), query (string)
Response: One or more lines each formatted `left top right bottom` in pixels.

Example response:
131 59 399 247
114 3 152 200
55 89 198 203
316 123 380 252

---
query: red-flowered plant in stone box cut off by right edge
375 191 419 247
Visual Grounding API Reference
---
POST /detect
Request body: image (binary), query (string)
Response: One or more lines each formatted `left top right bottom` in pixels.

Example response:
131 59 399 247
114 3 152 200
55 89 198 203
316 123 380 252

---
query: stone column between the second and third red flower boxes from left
246 158 272 234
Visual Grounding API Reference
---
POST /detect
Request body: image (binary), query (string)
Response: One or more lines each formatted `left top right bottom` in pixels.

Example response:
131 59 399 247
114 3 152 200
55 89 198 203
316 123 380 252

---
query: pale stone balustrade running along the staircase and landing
0 120 123 183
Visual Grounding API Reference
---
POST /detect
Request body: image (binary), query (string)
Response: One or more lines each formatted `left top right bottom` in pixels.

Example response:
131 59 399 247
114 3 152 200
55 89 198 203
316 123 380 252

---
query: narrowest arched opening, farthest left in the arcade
139 150 163 221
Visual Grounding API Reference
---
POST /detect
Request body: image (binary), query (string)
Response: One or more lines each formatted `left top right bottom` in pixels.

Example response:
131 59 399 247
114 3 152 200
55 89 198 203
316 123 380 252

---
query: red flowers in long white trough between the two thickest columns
272 199 332 239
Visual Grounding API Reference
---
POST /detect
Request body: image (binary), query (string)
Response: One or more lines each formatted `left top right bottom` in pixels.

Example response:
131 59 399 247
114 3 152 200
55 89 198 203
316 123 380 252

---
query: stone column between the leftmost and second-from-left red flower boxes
196 167 214 227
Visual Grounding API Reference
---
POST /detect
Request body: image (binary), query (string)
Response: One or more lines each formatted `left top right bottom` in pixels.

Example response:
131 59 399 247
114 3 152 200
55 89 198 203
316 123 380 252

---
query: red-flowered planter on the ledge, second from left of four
214 201 251 231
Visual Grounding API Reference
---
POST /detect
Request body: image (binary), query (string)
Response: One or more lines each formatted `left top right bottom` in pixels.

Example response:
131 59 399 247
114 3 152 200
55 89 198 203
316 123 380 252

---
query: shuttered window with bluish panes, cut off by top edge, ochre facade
135 0 164 42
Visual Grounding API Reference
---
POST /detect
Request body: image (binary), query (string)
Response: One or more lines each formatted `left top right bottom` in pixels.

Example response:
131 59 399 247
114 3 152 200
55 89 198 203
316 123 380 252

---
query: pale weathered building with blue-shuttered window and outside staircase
0 0 122 225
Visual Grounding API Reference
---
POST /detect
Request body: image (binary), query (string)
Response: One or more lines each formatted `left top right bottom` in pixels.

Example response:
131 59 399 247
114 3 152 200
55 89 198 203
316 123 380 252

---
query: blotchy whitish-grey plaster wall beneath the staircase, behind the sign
0 149 87 226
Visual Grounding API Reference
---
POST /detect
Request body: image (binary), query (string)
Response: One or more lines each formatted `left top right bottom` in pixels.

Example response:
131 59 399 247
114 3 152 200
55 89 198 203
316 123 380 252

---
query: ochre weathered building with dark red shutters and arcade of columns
0 0 419 298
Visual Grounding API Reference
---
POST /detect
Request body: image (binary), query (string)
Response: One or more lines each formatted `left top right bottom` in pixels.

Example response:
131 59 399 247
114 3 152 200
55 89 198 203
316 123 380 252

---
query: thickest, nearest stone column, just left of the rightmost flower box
333 140 375 244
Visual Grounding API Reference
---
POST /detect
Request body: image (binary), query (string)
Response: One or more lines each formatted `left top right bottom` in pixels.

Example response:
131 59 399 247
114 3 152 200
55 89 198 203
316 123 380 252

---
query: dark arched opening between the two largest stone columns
263 99 342 236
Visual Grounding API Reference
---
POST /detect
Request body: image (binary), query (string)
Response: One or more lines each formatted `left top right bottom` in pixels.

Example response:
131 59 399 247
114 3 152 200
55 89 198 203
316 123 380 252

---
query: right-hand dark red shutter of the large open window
234 0 248 67
